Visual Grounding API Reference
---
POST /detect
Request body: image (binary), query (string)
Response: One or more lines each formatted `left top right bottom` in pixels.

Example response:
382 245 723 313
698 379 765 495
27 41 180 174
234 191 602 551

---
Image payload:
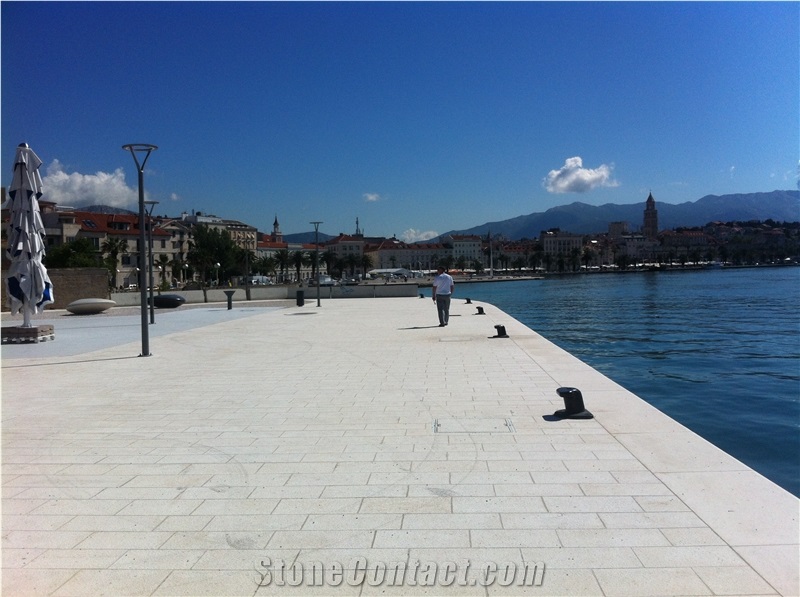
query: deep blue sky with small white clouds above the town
0 2 800 240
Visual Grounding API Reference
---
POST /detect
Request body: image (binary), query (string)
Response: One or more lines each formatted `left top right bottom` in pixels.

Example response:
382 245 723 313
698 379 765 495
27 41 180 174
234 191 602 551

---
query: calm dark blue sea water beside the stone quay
456 267 800 496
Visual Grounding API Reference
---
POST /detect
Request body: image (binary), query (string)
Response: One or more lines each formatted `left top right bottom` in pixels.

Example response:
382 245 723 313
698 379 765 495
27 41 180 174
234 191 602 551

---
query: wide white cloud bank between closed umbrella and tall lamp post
42 160 139 208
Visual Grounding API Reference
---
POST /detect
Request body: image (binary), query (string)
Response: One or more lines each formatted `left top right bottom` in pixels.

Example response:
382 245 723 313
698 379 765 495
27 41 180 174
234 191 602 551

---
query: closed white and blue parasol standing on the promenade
6 143 53 327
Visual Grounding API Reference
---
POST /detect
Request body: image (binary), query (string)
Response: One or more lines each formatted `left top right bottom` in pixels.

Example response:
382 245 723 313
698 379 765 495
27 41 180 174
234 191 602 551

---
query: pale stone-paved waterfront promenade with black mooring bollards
2 298 800 597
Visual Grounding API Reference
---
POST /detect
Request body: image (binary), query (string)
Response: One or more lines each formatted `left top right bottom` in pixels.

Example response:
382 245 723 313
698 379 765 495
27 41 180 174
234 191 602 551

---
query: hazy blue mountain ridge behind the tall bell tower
442 191 800 240
